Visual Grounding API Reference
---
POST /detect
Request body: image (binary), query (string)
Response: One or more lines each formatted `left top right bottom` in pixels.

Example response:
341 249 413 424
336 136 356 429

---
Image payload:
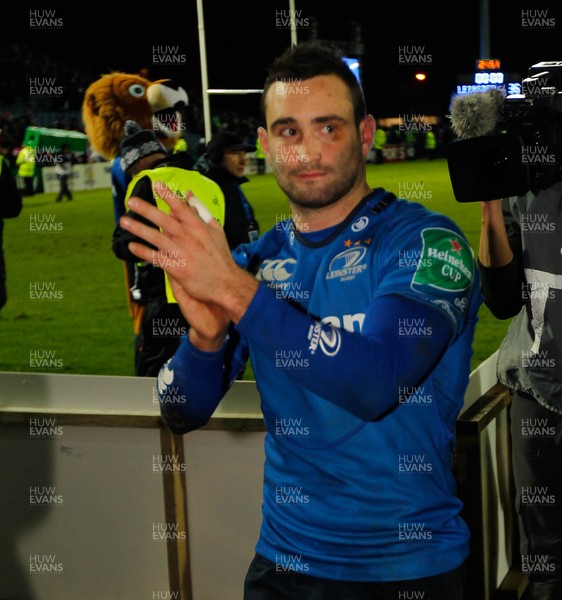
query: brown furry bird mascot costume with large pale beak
82 72 188 356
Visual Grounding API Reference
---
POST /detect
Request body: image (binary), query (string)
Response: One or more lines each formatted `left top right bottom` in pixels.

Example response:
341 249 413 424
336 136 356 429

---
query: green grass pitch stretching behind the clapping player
0 159 509 377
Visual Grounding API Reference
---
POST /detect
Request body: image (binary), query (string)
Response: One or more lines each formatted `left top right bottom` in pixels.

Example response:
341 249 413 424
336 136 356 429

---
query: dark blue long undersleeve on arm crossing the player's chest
236 284 452 421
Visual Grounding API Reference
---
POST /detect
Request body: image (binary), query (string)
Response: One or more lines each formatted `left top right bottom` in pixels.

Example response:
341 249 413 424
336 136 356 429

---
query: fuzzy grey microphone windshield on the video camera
449 88 505 139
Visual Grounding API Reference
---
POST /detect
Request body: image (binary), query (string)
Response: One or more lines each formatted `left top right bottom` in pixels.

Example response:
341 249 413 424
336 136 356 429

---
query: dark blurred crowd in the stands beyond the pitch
0 41 452 173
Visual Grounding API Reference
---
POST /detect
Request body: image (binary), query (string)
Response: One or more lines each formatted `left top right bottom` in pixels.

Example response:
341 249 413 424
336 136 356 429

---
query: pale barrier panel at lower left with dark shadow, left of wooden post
0 421 169 600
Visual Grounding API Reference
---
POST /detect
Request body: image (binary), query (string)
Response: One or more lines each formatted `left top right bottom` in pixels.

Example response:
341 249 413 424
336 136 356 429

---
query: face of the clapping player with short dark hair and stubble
259 75 370 208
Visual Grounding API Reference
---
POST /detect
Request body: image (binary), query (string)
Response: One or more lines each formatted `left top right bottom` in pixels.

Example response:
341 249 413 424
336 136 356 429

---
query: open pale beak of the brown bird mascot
146 79 189 138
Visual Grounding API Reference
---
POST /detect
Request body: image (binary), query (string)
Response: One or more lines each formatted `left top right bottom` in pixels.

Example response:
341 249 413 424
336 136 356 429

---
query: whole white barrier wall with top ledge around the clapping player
0 357 509 600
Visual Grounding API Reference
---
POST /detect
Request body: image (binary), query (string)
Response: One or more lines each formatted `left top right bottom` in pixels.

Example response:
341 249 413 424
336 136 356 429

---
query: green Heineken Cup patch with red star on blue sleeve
412 227 474 292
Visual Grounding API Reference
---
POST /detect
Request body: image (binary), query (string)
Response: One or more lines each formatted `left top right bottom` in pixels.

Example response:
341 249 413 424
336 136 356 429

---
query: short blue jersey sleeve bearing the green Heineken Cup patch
374 215 478 334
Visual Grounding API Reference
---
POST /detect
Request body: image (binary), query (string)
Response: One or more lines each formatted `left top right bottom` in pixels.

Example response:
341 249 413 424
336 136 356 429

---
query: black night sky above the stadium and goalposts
4 0 562 117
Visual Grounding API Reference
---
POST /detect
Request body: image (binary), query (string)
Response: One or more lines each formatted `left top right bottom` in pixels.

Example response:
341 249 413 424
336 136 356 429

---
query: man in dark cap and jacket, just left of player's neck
194 131 260 249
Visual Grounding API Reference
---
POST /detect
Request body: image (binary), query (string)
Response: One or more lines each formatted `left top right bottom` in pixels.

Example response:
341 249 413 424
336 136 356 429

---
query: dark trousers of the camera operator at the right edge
511 392 562 600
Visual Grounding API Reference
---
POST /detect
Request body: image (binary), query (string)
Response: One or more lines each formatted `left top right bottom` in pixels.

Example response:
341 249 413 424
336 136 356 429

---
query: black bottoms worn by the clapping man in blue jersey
244 555 463 600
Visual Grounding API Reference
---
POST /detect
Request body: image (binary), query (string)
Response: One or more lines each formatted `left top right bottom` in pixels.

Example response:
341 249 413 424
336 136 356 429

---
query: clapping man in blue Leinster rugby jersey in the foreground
122 43 481 600
